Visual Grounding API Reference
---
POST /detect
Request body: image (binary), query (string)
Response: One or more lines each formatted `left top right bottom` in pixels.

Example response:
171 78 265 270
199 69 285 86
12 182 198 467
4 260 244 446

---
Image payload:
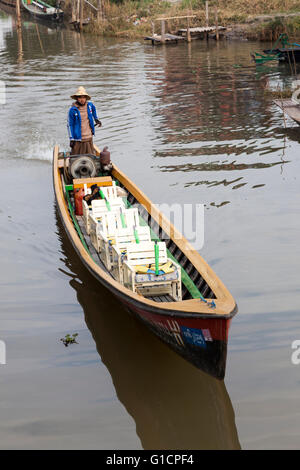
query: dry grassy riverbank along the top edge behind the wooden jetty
57 0 300 41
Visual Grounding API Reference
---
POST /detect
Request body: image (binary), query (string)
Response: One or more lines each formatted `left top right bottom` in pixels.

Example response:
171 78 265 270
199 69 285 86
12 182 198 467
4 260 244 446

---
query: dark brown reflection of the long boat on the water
57 215 240 449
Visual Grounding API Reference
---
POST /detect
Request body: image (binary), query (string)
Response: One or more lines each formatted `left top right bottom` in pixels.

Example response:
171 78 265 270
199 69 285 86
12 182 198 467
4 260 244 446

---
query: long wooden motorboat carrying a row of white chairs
53 146 237 379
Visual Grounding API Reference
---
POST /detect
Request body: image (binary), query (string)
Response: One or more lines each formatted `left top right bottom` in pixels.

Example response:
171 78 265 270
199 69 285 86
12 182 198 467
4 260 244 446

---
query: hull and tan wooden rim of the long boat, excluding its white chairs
53 146 237 379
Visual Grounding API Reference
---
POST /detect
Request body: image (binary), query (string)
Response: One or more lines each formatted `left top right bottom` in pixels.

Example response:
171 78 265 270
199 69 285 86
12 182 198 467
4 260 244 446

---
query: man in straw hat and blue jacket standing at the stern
68 86 102 155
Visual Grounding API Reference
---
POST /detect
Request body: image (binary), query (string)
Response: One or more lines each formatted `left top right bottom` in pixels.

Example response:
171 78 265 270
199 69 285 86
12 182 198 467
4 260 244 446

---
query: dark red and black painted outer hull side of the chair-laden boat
58 196 231 379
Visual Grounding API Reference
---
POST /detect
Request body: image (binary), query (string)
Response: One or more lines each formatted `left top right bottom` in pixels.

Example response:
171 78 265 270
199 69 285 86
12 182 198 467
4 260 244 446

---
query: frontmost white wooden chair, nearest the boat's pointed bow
123 242 182 301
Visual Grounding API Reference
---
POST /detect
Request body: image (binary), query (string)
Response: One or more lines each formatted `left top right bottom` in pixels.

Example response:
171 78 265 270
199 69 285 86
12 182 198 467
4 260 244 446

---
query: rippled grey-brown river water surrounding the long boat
0 10 300 449
